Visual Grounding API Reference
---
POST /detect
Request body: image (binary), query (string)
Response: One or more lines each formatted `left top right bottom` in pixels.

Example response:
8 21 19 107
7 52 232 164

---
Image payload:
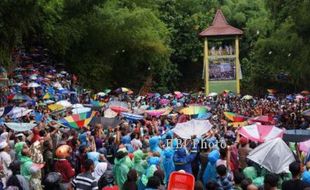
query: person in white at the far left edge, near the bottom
0 141 12 188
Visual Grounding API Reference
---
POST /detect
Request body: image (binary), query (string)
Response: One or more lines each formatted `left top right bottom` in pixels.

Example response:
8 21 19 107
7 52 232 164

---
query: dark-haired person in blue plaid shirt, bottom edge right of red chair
216 164 233 190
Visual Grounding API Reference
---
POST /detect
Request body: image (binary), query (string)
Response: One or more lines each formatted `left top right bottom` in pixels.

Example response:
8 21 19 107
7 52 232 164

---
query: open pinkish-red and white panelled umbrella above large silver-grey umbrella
239 123 284 142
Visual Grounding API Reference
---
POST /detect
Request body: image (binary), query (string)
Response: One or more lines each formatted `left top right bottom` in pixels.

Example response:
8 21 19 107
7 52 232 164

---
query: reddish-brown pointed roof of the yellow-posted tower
199 9 243 37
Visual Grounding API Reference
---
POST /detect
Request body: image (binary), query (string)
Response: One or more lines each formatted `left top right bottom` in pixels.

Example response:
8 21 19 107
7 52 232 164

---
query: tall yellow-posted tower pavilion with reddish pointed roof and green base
199 9 243 94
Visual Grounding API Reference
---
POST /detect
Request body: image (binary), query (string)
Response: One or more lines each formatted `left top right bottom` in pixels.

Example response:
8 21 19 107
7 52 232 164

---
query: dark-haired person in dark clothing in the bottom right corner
282 161 310 190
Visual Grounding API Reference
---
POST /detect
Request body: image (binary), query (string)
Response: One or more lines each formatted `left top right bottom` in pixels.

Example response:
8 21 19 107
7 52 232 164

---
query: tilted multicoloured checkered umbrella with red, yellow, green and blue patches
59 112 96 129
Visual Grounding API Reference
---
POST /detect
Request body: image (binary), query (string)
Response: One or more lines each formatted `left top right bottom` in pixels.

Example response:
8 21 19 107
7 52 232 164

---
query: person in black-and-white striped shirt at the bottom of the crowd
71 159 98 190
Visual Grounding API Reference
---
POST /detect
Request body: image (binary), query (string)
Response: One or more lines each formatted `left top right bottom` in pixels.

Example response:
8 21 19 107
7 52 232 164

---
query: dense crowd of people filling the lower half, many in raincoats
0 47 310 190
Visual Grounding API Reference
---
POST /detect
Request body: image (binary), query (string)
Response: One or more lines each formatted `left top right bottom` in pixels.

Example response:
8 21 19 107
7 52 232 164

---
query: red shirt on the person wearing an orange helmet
55 159 75 183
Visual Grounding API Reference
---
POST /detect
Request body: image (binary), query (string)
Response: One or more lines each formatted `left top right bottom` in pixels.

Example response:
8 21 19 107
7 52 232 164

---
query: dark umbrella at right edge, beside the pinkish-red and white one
283 129 310 142
